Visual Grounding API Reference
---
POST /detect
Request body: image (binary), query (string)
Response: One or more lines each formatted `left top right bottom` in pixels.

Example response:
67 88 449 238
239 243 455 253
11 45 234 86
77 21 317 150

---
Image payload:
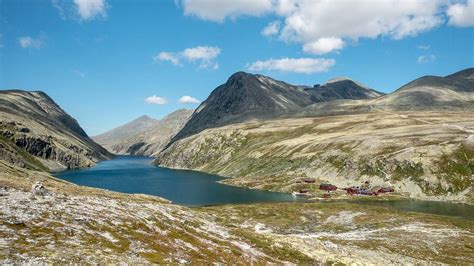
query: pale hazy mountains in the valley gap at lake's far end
92 109 194 156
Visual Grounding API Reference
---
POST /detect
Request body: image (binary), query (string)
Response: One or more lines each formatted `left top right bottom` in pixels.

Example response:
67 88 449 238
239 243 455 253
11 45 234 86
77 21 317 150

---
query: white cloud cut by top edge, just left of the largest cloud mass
182 0 273 22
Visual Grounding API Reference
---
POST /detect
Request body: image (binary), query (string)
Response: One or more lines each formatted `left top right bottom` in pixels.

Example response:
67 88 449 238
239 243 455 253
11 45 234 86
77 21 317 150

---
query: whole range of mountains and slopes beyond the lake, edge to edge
0 68 474 202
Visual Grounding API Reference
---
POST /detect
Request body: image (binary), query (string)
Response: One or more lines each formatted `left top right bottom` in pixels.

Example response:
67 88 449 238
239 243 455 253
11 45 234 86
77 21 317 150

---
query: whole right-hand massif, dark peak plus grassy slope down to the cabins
155 68 474 202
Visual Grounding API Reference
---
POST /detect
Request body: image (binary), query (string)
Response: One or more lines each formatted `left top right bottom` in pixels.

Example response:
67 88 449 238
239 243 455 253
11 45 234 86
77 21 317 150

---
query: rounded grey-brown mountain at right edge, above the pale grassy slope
296 68 474 116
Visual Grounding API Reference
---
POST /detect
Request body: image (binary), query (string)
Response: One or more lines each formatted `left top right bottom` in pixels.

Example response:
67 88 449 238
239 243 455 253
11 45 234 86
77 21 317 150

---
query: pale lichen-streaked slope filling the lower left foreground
0 162 278 263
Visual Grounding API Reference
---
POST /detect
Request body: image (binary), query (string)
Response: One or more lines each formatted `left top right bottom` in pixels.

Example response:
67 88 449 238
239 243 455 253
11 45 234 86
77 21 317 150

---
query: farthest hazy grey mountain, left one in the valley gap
92 115 159 150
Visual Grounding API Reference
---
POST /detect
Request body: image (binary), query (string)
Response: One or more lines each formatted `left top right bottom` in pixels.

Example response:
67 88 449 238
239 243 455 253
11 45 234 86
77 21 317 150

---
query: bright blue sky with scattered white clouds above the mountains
0 0 474 136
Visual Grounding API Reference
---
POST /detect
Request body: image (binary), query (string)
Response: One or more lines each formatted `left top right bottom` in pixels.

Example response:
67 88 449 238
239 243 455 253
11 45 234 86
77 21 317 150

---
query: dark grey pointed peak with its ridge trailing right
172 72 383 142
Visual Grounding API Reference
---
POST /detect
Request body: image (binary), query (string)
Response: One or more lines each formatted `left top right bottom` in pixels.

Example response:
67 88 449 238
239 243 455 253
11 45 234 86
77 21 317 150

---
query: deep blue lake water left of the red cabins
55 156 297 206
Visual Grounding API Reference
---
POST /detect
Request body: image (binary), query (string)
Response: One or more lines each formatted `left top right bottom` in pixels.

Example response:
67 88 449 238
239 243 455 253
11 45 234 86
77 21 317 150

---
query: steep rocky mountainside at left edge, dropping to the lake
0 90 112 170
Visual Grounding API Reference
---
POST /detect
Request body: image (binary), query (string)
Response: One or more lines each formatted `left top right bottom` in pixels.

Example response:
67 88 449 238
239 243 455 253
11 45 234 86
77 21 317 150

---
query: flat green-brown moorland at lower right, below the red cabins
201 202 474 265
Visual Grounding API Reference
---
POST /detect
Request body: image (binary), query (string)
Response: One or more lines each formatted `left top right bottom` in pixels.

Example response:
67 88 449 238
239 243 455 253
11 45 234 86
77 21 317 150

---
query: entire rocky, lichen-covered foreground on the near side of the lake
0 161 474 264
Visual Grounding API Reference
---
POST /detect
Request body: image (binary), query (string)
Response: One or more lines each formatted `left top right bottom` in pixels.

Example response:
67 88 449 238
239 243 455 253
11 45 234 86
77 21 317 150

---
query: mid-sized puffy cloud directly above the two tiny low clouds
153 46 221 69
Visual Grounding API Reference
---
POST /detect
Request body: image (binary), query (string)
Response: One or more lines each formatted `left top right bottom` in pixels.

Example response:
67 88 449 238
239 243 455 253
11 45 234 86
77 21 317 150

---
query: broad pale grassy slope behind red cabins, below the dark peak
156 109 474 204
